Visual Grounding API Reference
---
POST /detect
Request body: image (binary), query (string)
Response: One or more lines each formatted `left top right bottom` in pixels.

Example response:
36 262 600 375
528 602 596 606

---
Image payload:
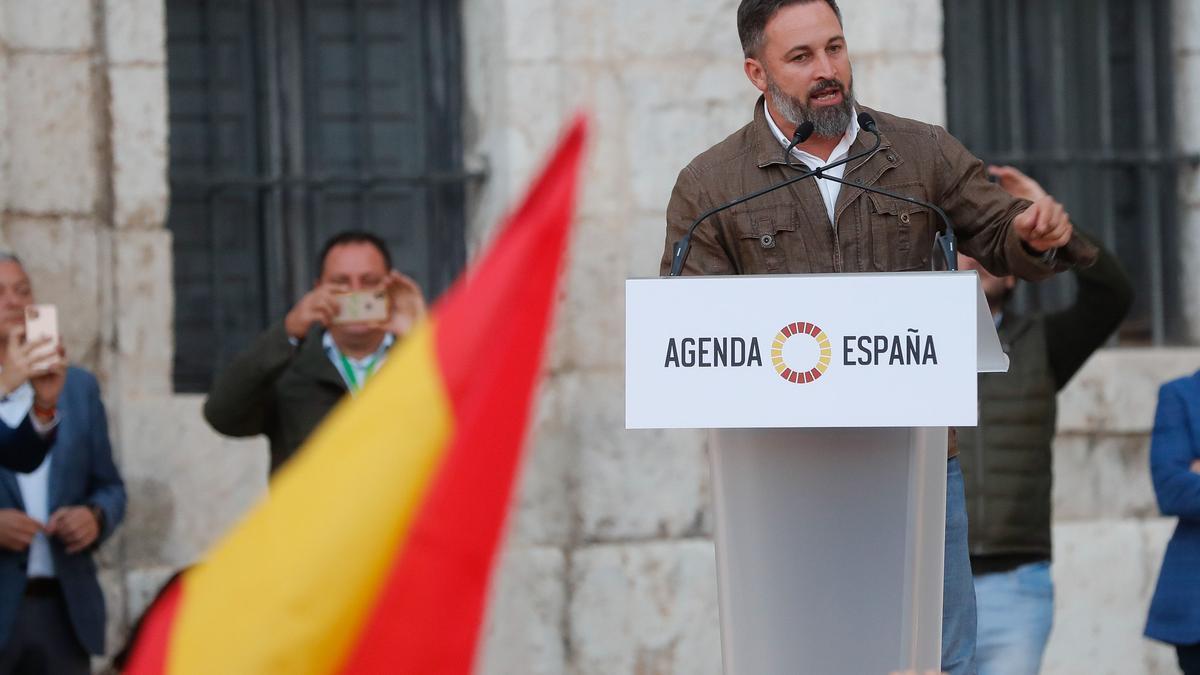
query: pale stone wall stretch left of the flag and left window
0 0 266 649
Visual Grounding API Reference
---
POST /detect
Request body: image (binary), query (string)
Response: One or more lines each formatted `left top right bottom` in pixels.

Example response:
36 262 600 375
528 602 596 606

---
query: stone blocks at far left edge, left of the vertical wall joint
0 0 112 368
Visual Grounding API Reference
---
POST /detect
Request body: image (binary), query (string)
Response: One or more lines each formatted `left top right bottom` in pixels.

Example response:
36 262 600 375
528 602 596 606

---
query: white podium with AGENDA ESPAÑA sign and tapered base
625 271 1008 675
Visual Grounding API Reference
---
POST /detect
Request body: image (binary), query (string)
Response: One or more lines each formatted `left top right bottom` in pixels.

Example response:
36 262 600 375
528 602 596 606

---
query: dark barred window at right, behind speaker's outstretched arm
943 0 1200 345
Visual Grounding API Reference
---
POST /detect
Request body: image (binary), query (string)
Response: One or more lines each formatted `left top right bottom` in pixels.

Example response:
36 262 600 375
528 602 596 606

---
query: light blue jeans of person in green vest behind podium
976 561 1054 675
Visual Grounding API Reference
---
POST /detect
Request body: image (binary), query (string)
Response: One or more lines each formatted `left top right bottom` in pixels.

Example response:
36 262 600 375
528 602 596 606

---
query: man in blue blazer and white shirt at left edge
0 256 125 675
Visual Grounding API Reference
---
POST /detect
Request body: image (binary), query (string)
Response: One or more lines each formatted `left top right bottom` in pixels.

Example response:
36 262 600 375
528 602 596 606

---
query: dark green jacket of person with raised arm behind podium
959 239 1133 573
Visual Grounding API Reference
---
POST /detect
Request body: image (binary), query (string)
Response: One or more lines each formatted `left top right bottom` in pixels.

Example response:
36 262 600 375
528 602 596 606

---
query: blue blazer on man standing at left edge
0 366 125 655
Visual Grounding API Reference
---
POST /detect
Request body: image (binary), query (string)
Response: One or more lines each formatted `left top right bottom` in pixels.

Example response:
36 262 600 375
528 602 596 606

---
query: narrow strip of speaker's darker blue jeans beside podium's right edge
942 458 976 675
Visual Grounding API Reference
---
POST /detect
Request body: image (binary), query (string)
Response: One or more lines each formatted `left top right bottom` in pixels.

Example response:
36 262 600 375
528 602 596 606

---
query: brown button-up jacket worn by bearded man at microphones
660 97 1096 456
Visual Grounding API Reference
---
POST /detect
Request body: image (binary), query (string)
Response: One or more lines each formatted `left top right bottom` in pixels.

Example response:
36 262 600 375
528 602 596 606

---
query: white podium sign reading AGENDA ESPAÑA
625 273 1007 429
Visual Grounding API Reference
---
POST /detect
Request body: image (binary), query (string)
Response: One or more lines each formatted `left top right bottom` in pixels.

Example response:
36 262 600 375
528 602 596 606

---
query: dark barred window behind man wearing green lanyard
167 0 478 392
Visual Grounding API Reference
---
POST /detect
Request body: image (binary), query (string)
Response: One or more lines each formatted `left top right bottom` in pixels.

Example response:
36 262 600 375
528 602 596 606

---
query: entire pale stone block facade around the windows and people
0 0 1200 675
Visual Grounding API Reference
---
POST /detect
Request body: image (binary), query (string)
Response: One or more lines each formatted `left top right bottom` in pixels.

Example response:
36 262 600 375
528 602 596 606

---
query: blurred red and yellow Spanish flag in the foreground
126 117 587 675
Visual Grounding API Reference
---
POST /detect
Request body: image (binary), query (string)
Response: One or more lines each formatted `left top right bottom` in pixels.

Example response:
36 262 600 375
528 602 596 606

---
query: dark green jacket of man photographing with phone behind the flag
204 322 347 473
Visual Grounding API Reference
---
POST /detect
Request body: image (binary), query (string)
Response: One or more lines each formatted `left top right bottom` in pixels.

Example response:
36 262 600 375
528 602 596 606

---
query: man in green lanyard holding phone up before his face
204 231 425 473
